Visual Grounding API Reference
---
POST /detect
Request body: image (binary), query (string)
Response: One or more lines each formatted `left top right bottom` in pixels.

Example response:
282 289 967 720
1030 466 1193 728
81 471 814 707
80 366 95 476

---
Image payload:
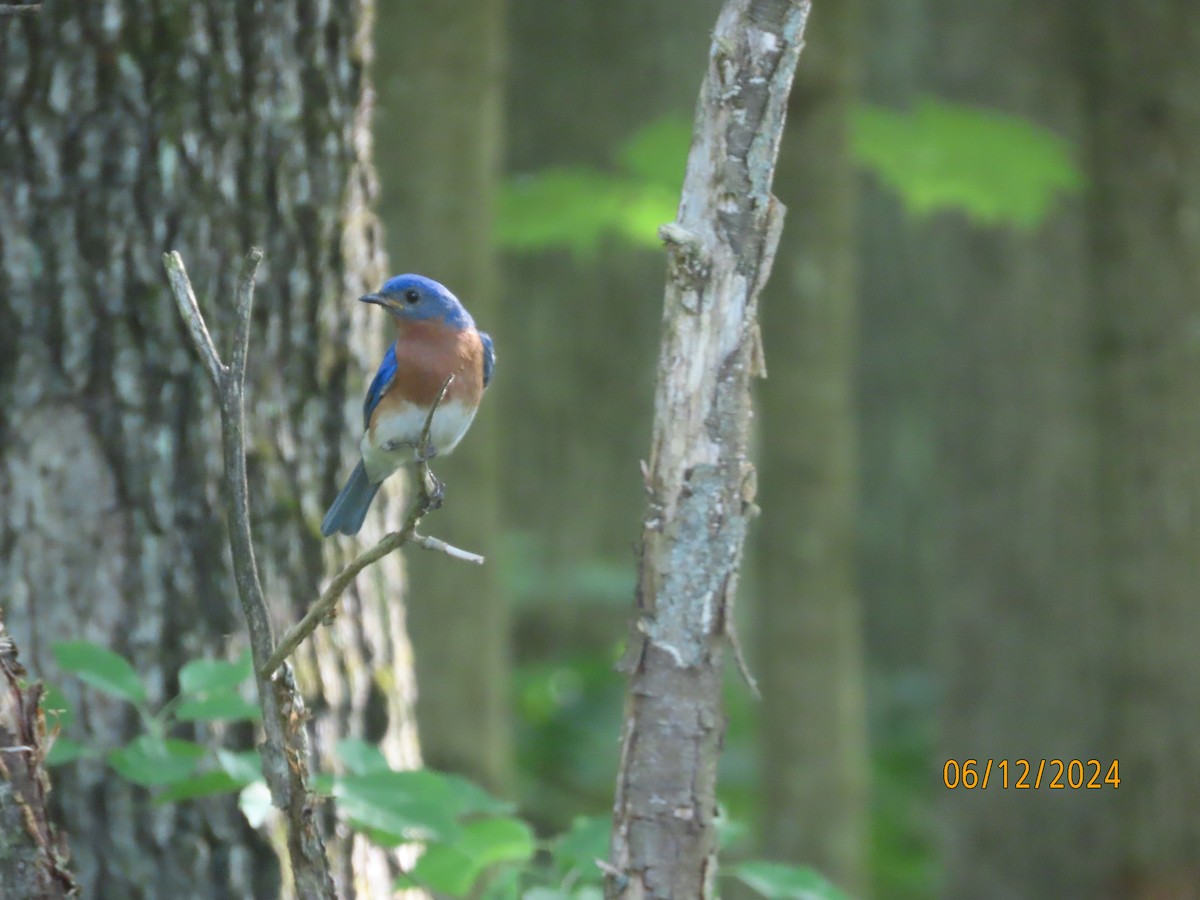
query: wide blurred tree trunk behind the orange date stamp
926 0 1115 899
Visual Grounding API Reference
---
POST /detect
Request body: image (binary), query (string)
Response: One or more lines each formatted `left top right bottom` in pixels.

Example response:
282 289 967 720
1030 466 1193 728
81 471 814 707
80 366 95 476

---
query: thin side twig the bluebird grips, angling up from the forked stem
259 374 484 678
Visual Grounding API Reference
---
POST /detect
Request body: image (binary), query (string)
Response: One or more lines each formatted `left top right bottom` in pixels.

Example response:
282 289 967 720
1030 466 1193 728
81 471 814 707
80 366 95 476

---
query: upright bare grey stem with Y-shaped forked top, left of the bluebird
163 248 335 900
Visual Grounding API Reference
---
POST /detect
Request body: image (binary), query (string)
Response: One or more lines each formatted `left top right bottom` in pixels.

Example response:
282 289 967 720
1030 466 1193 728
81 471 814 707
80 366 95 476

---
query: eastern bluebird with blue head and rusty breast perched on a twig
320 275 496 538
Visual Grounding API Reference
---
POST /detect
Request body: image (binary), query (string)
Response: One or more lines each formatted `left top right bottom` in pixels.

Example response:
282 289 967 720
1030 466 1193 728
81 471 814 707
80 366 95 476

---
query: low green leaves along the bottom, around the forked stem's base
44 642 842 900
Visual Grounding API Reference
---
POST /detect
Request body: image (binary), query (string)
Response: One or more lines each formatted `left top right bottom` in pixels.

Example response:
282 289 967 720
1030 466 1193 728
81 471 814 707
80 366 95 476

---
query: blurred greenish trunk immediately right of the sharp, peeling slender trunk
756 2 868 895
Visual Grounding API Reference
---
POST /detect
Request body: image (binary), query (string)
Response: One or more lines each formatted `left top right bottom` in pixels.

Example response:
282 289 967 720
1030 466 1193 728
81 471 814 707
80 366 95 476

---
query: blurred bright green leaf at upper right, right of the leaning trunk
853 97 1084 229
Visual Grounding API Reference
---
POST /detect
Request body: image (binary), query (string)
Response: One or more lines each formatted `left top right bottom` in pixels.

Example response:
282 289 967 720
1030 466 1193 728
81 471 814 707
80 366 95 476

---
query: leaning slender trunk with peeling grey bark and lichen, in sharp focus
606 0 809 898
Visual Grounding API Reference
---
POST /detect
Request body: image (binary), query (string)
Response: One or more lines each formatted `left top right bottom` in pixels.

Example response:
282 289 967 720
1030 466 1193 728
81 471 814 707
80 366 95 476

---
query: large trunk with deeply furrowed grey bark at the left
0 0 418 898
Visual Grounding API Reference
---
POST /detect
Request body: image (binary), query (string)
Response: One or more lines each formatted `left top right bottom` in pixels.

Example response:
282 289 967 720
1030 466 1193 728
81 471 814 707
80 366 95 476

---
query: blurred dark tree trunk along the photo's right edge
1080 0 1200 899
